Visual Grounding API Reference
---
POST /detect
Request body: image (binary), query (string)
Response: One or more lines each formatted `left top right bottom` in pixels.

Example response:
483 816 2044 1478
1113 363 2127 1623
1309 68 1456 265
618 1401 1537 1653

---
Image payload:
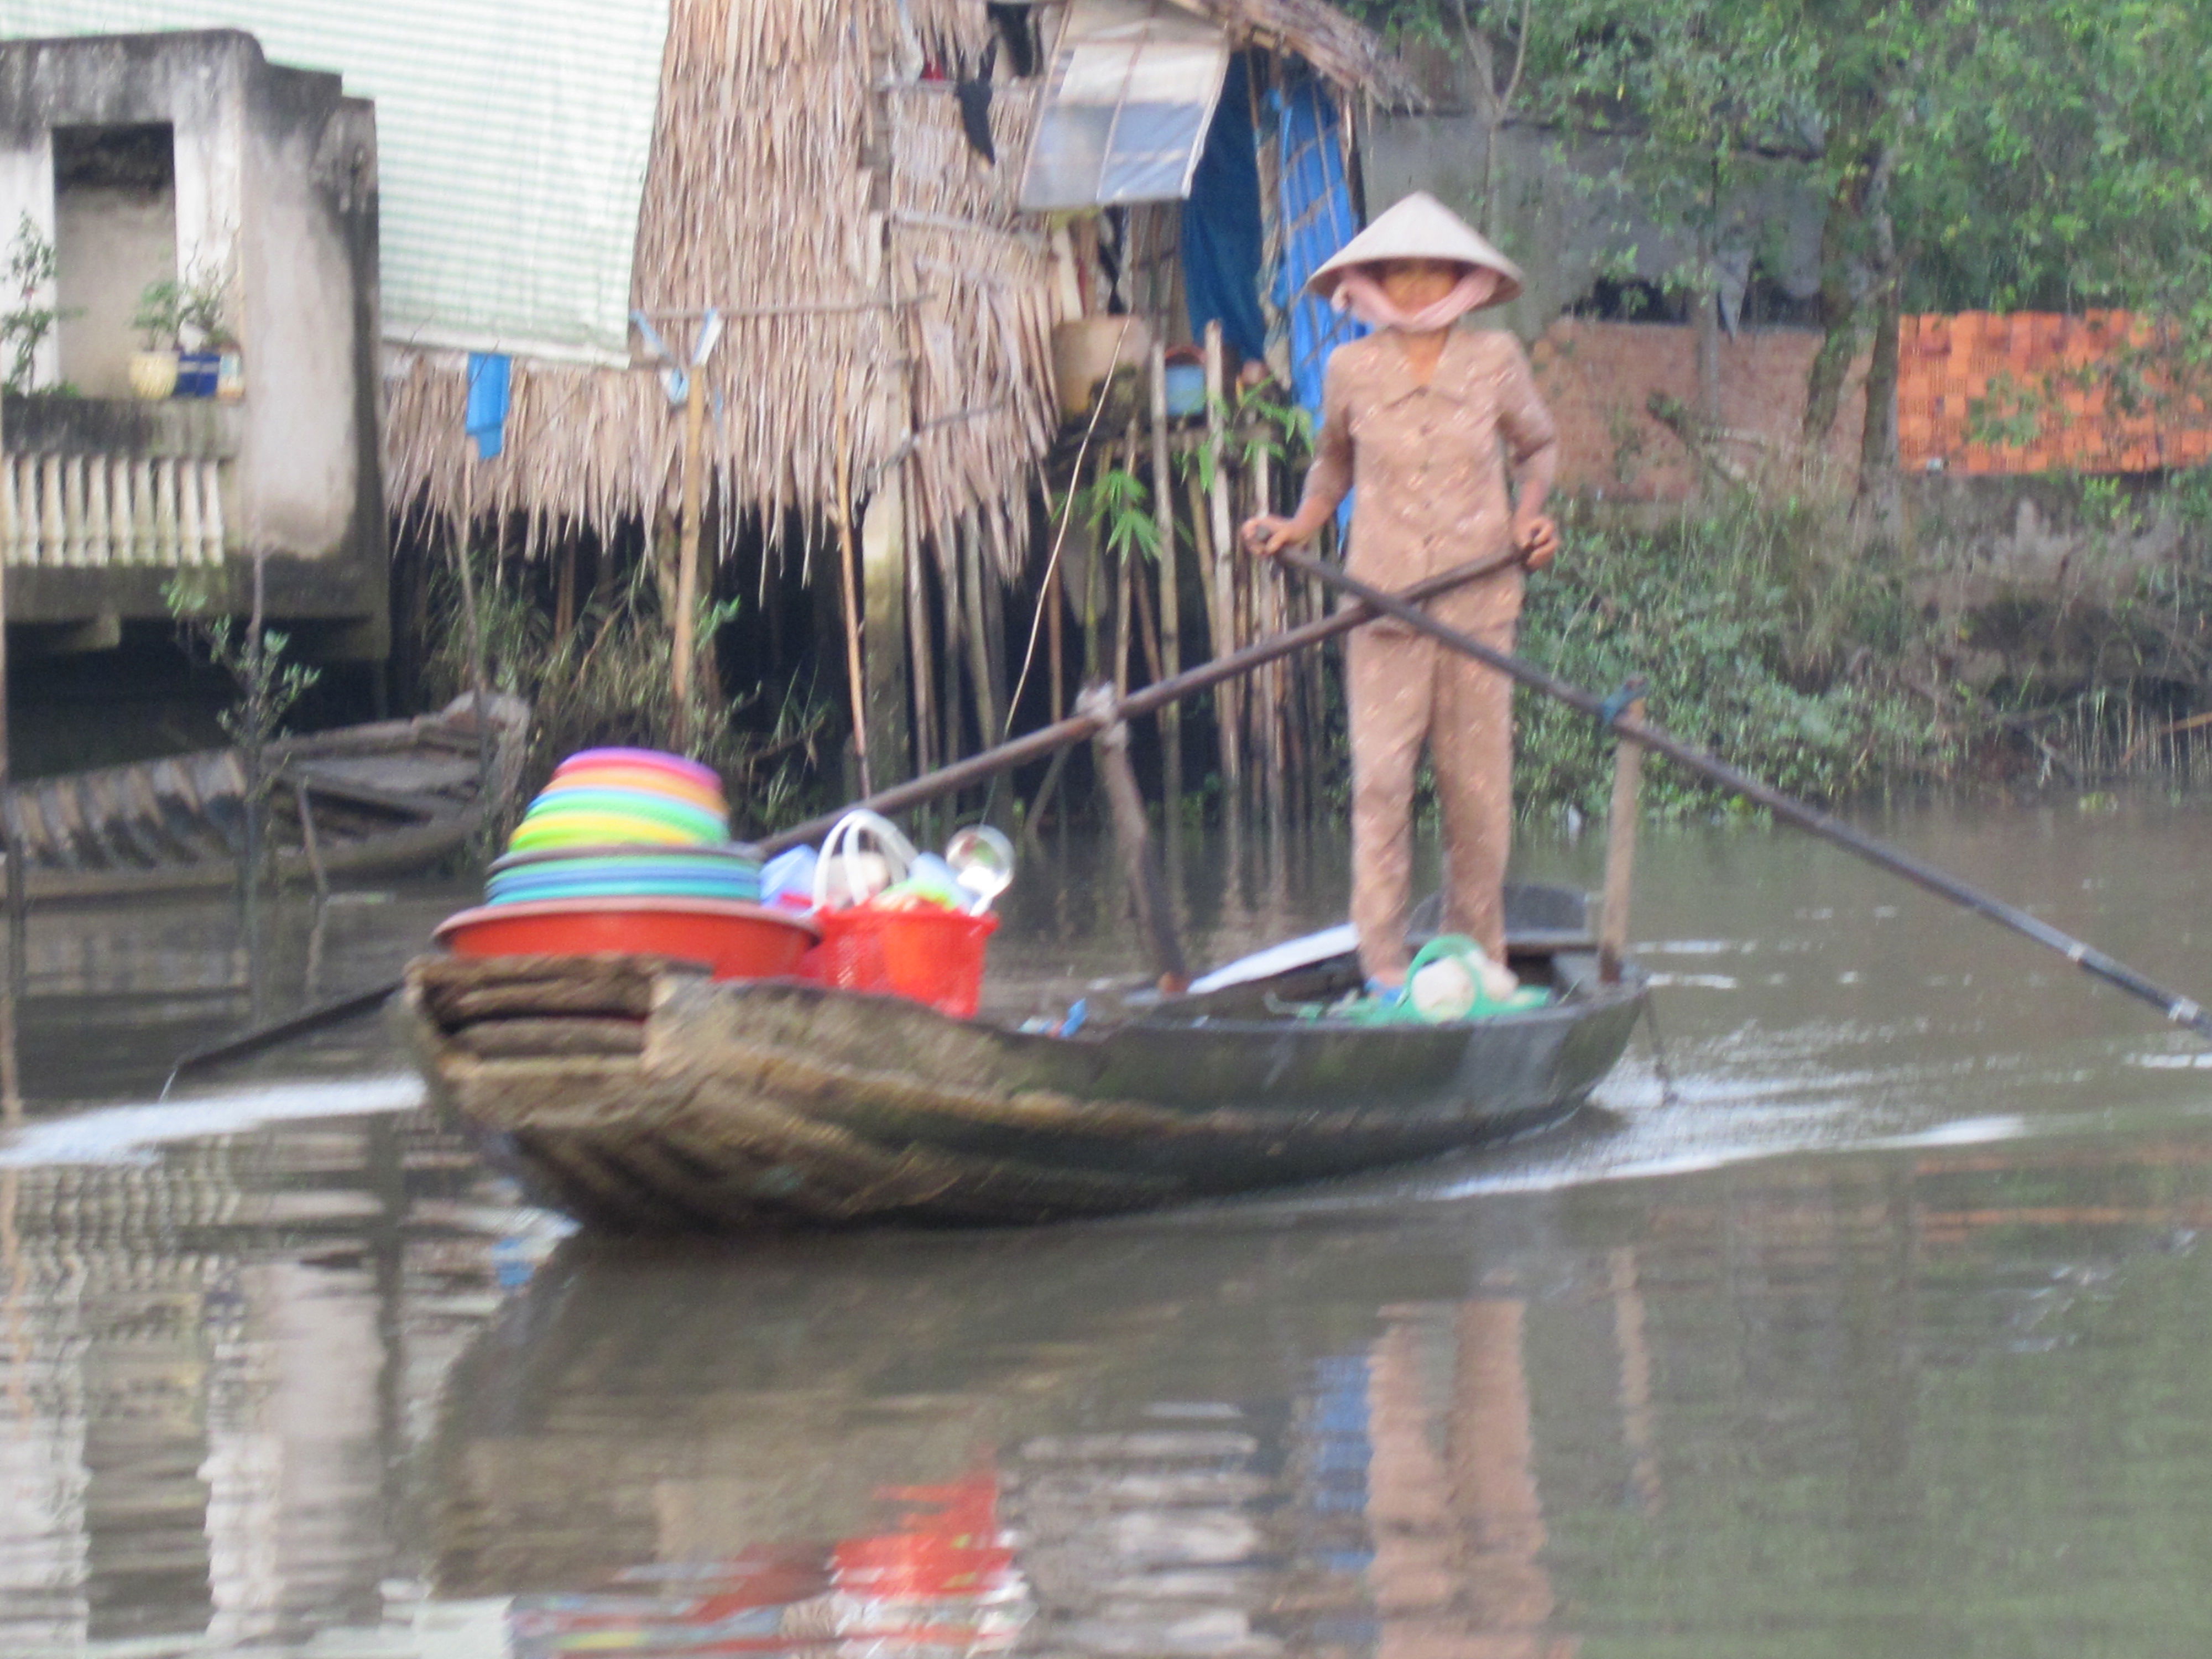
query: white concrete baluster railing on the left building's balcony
0 398 241 568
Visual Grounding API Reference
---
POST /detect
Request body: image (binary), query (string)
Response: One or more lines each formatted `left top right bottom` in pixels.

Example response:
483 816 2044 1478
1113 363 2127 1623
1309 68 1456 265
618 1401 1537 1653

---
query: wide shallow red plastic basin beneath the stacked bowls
438 898 818 980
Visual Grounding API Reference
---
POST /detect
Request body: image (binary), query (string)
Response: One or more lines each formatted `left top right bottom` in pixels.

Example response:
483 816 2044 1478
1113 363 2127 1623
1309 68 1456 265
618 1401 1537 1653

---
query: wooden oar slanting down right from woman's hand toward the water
1276 553 2212 1037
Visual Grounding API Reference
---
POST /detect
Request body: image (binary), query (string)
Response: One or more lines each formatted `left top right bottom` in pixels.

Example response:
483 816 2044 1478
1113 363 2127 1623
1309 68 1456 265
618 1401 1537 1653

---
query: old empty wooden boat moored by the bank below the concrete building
0 697 529 900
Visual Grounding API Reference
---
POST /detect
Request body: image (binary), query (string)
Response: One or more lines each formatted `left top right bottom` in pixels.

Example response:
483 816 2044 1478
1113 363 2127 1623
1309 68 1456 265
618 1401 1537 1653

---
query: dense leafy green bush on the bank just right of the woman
1515 493 1951 816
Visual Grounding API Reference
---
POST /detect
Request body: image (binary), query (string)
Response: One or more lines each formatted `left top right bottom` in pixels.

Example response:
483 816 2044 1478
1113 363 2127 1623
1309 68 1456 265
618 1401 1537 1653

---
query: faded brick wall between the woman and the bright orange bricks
1528 316 1865 502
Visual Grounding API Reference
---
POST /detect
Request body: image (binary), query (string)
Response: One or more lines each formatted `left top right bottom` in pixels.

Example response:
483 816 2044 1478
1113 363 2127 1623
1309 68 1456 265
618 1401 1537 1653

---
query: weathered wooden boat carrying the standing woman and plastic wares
396 887 1644 1232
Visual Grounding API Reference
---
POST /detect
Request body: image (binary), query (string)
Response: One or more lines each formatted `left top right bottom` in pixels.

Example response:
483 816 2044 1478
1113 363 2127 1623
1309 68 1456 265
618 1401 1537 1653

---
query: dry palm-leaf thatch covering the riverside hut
385 0 1389 557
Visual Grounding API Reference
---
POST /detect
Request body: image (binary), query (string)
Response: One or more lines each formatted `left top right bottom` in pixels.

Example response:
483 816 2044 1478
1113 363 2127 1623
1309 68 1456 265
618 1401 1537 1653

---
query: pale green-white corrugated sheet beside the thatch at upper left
0 0 668 363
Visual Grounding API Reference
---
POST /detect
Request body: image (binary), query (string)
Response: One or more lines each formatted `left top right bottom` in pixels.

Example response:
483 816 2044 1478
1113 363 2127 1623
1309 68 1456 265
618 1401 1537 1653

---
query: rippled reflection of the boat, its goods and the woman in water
418 1237 1575 1659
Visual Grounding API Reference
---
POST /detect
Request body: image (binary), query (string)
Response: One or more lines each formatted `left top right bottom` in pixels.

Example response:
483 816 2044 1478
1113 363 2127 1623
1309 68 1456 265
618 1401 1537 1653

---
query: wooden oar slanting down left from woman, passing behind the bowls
161 553 1520 1097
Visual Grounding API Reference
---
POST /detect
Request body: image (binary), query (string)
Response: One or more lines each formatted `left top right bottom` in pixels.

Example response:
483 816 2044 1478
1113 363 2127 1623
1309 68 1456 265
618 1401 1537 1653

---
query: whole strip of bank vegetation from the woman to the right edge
1515 473 2212 814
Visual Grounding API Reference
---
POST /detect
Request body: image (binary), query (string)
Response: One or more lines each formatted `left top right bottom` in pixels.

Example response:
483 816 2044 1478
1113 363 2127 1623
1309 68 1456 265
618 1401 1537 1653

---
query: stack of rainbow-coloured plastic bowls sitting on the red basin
484 750 761 905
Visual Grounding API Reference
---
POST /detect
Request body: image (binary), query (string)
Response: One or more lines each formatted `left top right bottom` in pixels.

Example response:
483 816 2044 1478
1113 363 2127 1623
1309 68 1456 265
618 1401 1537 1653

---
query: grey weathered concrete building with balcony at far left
0 31 389 659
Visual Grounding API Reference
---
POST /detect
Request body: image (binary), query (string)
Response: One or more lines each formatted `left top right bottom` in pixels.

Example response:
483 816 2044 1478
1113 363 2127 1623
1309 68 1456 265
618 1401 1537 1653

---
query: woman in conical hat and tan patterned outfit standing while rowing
1243 192 1559 989
